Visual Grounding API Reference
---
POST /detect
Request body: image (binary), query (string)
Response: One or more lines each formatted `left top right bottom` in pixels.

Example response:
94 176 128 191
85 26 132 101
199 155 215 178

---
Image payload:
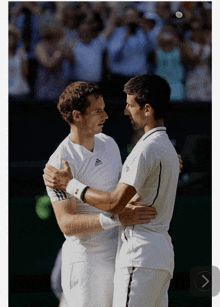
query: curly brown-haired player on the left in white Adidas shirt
44 82 156 307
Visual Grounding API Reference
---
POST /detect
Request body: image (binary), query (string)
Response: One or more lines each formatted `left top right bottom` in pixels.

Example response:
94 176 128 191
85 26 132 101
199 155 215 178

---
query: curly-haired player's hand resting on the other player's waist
118 197 157 226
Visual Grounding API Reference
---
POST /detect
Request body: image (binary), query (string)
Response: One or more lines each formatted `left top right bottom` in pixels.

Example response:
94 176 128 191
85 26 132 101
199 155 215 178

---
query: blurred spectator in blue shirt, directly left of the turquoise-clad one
107 7 152 95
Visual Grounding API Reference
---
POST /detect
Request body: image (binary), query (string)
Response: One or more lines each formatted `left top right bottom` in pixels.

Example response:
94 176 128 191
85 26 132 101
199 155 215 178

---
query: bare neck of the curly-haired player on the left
70 127 95 151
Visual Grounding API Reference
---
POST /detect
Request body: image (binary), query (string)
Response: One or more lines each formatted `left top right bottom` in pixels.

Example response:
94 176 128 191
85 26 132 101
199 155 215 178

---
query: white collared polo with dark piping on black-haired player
117 127 179 276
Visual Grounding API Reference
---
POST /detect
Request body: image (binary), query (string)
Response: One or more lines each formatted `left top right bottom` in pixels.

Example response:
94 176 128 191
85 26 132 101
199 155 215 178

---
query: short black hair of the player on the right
124 74 171 120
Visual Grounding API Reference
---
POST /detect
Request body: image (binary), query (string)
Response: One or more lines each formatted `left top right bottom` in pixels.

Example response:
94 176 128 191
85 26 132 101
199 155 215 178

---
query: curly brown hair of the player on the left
57 81 102 124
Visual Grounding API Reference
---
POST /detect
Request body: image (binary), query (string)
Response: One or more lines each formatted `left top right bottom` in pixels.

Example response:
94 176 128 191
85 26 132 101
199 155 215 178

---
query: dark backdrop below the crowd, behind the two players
9 98 211 307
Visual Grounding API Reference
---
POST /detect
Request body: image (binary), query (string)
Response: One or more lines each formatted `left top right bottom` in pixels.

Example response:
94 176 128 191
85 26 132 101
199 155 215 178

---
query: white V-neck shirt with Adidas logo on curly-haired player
47 133 122 262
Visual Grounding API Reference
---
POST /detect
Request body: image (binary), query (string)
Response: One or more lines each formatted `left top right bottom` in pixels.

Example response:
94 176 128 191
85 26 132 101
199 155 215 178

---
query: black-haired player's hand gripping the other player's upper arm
43 160 73 191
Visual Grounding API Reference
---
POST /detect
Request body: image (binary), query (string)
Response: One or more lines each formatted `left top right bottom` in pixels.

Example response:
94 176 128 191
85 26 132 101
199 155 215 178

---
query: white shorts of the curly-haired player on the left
61 242 115 307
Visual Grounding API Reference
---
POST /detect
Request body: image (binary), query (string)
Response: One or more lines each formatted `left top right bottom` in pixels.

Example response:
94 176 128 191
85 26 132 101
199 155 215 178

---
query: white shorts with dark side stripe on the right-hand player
112 267 171 307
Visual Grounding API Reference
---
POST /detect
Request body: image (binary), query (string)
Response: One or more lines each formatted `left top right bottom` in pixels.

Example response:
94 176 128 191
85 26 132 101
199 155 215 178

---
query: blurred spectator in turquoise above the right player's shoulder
155 26 185 100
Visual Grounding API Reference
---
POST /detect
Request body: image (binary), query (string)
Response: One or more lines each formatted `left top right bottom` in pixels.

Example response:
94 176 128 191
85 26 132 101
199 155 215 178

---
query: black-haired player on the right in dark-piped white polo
46 74 179 307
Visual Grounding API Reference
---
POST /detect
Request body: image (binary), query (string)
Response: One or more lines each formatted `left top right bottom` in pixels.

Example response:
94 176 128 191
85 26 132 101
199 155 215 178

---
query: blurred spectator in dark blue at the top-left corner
10 1 42 95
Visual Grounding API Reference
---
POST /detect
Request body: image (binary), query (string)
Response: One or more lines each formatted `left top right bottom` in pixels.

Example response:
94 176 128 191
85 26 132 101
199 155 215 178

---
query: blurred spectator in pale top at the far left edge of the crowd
9 24 30 99
